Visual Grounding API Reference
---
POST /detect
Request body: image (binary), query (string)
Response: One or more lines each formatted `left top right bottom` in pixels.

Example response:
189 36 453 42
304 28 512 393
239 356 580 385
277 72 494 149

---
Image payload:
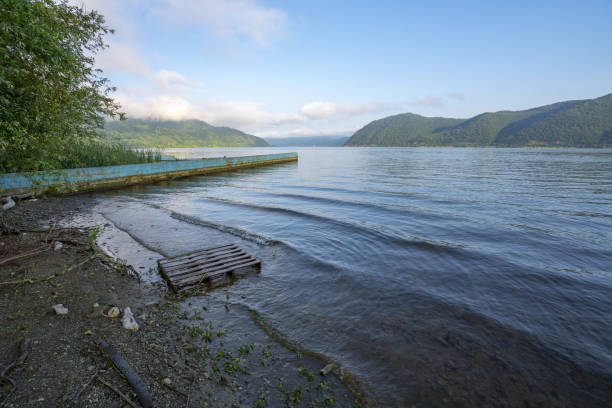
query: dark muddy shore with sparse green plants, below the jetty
0 195 361 407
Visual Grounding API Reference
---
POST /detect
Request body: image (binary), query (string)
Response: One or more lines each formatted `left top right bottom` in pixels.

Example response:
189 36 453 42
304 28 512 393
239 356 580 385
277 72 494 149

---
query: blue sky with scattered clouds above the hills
73 0 612 137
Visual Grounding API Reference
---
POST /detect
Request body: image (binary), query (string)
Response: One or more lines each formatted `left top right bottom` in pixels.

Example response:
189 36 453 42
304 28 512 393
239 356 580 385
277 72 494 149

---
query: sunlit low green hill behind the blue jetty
104 119 268 148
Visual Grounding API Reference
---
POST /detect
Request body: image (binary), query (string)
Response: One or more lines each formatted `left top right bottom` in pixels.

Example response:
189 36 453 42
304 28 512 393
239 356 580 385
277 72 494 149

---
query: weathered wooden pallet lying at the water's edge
157 244 261 292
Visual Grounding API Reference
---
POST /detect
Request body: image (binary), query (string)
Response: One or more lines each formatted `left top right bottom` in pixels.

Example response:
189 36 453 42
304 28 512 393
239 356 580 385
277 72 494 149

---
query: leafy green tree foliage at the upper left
0 0 123 172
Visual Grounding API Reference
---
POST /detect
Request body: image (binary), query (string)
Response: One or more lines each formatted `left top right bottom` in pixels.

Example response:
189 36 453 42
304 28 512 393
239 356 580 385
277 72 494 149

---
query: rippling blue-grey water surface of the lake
94 148 612 406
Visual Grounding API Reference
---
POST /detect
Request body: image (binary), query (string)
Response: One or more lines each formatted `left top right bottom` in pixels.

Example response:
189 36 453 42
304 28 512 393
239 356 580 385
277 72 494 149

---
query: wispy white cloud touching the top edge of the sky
155 0 288 46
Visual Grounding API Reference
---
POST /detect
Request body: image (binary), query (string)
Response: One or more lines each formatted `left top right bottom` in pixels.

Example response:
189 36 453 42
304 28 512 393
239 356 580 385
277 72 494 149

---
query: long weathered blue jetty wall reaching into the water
0 153 298 196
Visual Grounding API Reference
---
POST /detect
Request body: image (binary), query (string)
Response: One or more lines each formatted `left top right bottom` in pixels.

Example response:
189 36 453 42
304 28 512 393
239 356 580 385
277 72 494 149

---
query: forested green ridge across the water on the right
345 94 612 147
